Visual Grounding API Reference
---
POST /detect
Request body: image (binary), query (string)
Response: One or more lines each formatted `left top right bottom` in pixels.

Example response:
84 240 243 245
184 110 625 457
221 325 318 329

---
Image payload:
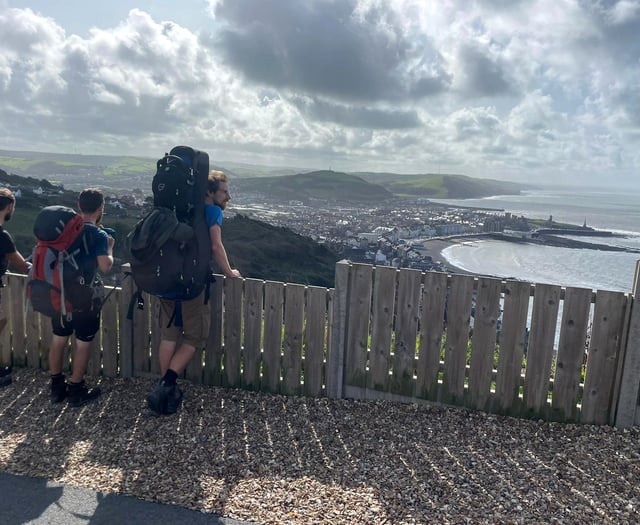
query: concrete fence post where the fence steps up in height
327 259 351 399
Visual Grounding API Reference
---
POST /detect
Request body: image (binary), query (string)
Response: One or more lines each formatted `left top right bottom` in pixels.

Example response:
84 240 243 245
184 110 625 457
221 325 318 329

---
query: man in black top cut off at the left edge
0 188 29 387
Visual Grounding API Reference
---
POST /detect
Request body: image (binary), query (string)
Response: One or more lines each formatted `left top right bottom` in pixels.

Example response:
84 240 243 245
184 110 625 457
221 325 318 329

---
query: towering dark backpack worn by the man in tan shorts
127 146 211 318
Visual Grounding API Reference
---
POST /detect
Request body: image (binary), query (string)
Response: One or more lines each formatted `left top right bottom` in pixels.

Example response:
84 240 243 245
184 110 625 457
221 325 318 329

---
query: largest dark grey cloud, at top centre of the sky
209 0 451 102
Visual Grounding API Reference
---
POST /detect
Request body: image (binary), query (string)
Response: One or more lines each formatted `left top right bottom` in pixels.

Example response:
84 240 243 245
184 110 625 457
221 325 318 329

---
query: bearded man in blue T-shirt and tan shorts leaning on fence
147 170 242 415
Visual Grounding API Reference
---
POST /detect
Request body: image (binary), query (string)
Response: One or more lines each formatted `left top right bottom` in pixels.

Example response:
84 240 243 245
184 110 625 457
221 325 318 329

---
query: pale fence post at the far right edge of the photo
615 261 640 428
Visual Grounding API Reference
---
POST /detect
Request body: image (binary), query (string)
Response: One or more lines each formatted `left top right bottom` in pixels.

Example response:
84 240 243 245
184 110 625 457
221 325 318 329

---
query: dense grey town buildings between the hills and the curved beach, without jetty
228 194 532 271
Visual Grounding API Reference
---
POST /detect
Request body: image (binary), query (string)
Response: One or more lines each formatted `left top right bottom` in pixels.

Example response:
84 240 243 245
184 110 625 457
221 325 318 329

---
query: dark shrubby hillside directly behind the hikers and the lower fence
0 170 338 287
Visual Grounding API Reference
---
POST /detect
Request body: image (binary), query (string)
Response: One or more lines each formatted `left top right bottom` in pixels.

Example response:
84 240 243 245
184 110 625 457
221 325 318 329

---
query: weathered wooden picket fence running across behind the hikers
0 261 640 426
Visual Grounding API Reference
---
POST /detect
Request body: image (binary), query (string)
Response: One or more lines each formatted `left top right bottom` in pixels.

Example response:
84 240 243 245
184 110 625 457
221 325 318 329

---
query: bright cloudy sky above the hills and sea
0 0 640 187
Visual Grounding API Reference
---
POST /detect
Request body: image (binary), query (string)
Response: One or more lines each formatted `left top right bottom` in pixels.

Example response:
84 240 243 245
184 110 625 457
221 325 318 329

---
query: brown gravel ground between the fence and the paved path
0 369 640 524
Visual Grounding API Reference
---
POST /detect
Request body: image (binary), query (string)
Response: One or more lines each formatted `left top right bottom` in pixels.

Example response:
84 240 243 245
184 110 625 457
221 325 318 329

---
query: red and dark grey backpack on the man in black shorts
27 206 101 319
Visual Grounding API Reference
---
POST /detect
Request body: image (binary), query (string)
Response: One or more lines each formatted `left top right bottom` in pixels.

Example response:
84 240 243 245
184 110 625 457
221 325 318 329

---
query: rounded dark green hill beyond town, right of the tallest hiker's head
233 170 393 204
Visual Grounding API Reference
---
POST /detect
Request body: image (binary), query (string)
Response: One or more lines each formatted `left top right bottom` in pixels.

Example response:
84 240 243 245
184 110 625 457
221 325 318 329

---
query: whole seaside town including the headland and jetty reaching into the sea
227 183 634 271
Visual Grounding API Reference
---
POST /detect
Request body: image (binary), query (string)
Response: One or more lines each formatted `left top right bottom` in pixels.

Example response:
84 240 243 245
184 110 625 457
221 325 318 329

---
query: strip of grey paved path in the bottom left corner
0 472 255 525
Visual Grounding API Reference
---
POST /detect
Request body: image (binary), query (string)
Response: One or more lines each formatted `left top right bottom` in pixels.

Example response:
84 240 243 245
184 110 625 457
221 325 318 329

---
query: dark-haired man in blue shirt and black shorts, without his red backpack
49 188 115 407
